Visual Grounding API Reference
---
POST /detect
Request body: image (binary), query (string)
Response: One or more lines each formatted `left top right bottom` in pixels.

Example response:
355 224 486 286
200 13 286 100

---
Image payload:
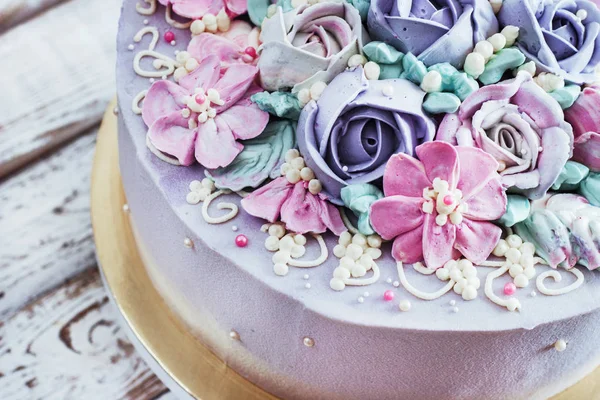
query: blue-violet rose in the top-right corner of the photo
498 0 600 83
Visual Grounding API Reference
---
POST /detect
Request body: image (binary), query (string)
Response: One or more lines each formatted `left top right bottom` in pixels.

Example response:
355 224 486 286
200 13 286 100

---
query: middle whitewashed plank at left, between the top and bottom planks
0 129 96 318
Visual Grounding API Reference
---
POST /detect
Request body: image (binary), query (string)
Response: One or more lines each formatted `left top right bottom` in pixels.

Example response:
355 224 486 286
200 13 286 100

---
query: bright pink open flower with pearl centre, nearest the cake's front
371 141 506 269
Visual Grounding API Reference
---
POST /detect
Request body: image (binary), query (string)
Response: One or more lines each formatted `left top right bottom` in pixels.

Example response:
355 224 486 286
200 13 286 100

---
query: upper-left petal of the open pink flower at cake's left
142 80 189 126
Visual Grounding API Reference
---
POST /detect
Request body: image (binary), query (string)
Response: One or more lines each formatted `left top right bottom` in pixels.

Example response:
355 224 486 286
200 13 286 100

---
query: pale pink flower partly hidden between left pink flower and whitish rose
187 20 260 68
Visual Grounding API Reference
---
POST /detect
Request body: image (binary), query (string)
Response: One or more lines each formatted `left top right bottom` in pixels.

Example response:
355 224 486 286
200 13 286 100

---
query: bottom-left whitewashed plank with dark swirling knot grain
0 269 169 400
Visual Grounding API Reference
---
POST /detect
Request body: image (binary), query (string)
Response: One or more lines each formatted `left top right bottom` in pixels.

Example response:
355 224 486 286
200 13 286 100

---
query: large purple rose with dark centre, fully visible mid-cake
297 67 435 204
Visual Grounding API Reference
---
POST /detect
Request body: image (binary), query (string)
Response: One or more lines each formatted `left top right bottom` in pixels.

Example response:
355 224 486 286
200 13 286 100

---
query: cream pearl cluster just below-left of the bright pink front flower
329 232 382 291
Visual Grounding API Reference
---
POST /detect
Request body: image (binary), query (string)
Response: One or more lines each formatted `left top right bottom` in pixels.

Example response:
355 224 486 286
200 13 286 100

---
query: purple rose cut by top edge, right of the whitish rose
368 0 498 68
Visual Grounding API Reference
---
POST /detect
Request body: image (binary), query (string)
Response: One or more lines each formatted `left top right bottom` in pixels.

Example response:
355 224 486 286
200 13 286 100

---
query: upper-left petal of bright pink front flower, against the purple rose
383 153 431 198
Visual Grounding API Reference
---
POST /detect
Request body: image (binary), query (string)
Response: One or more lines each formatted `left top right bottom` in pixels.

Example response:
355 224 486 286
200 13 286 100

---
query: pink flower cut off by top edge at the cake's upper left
158 0 248 19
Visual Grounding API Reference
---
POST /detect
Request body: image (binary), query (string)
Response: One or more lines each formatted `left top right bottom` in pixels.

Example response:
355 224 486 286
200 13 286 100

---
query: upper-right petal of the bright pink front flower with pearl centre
456 146 498 200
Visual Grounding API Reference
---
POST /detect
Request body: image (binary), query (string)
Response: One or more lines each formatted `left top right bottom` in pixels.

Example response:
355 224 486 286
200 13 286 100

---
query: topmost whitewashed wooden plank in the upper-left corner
0 0 121 178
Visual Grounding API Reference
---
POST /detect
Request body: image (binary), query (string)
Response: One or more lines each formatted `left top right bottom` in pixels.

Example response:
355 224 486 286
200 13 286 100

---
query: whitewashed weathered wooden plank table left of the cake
0 0 174 400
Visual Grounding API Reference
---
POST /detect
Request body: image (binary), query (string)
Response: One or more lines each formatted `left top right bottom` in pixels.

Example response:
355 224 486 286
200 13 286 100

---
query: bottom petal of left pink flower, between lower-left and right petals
196 115 244 169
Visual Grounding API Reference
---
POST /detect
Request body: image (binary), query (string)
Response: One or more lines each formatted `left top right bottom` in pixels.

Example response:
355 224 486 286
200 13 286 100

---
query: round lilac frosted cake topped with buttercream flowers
117 0 600 399
